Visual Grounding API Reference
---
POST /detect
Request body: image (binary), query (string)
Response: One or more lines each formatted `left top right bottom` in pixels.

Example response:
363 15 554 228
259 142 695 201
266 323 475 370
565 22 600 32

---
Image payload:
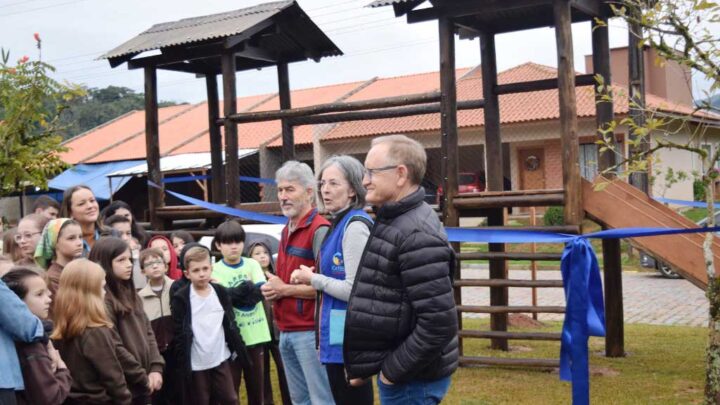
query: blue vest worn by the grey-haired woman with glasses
318 209 372 364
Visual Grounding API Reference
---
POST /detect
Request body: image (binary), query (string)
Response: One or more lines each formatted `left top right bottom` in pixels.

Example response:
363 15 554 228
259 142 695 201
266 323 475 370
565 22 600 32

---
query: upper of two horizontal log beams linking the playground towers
218 91 440 124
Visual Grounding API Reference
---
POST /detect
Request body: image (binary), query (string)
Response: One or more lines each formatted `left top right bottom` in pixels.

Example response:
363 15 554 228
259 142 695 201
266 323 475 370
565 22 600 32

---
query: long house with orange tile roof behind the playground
63 50 720 215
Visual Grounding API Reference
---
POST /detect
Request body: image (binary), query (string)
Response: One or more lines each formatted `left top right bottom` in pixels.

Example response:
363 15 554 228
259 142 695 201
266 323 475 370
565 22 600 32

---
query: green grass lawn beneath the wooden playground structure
252 319 707 405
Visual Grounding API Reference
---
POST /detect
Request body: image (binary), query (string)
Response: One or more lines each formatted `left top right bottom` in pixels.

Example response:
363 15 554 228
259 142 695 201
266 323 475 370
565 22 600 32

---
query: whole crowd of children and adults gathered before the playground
0 135 458 405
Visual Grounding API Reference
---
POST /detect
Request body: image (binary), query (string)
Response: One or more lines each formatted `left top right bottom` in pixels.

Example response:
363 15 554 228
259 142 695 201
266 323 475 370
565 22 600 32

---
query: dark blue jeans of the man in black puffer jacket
378 376 450 405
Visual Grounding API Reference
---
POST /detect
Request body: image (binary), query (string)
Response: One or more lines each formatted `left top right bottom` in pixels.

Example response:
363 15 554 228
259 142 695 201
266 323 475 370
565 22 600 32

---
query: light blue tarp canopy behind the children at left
48 160 144 200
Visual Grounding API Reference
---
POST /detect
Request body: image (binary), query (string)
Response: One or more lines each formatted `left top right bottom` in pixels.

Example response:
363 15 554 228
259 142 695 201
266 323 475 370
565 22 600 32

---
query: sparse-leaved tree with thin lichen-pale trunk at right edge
598 0 720 404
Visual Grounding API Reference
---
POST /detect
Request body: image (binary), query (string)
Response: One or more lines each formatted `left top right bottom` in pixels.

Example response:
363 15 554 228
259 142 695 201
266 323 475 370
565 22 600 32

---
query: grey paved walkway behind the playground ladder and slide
462 265 708 326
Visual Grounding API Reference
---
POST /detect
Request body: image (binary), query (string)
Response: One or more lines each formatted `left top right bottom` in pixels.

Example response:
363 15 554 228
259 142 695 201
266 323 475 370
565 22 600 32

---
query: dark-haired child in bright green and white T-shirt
212 220 271 405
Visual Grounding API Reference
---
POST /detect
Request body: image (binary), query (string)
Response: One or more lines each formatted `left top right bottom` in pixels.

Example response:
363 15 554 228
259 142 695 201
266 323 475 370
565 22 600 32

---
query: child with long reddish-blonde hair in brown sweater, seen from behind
50 259 148 404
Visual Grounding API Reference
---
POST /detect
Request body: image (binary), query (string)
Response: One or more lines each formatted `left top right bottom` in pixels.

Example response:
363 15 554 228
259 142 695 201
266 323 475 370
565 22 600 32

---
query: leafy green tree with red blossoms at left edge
0 48 83 195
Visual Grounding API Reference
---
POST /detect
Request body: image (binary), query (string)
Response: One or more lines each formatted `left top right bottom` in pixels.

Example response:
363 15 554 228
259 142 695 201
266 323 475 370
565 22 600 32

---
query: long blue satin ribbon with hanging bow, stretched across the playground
148 181 720 405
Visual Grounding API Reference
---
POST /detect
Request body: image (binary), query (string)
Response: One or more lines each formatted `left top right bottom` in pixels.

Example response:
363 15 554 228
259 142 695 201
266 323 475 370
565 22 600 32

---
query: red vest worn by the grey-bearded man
273 209 330 332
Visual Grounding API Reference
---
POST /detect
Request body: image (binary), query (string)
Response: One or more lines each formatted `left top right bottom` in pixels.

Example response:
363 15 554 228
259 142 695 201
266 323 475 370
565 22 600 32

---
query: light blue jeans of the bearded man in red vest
280 331 335 405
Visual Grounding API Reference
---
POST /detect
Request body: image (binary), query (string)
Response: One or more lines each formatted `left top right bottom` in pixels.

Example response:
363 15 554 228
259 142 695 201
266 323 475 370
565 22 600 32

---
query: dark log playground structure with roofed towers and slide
104 0 720 367
